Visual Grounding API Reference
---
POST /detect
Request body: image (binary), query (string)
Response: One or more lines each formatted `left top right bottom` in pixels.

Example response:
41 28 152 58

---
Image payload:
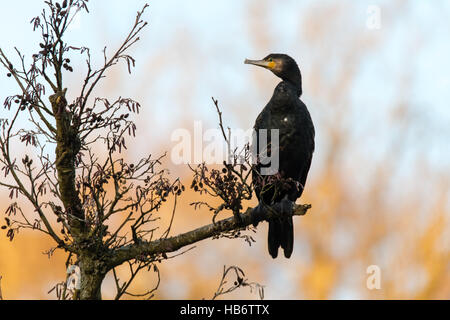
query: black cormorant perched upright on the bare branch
245 54 314 258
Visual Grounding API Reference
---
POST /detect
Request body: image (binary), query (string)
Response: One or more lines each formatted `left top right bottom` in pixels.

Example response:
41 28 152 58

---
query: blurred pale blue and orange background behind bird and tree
0 0 450 299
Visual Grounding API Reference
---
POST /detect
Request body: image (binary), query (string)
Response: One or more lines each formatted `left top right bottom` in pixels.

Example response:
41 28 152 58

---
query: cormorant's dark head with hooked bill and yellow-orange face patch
244 53 302 95
